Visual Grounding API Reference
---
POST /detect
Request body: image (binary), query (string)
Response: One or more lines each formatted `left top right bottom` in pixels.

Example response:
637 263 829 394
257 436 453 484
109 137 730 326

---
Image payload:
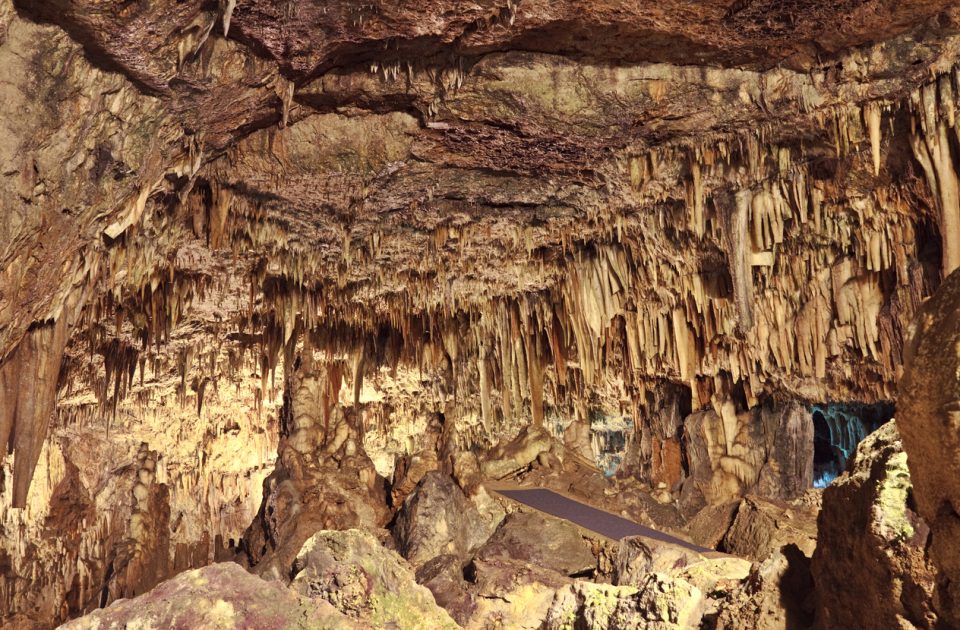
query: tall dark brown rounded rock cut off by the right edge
897 272 960 625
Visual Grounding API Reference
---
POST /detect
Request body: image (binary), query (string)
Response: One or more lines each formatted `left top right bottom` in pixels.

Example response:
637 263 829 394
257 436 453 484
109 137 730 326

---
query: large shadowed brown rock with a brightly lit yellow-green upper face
811 422 937 628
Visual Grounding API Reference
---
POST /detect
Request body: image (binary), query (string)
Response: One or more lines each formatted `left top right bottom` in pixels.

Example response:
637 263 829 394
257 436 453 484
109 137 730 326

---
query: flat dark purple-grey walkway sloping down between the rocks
495 488 716 554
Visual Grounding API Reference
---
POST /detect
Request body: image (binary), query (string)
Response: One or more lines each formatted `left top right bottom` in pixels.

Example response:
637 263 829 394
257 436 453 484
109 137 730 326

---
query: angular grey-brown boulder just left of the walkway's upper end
393 472 499 567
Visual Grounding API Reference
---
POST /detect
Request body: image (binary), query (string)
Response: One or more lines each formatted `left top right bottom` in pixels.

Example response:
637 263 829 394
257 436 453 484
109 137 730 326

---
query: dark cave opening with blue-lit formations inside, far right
810 402 894 488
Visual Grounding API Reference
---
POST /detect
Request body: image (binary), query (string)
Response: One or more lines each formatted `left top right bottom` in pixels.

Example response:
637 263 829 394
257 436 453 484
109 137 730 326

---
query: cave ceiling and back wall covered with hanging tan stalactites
0 0 960 623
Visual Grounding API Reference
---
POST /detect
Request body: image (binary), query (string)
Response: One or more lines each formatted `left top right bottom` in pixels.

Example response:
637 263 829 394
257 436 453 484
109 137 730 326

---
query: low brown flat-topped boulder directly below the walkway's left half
476 512 597 575
